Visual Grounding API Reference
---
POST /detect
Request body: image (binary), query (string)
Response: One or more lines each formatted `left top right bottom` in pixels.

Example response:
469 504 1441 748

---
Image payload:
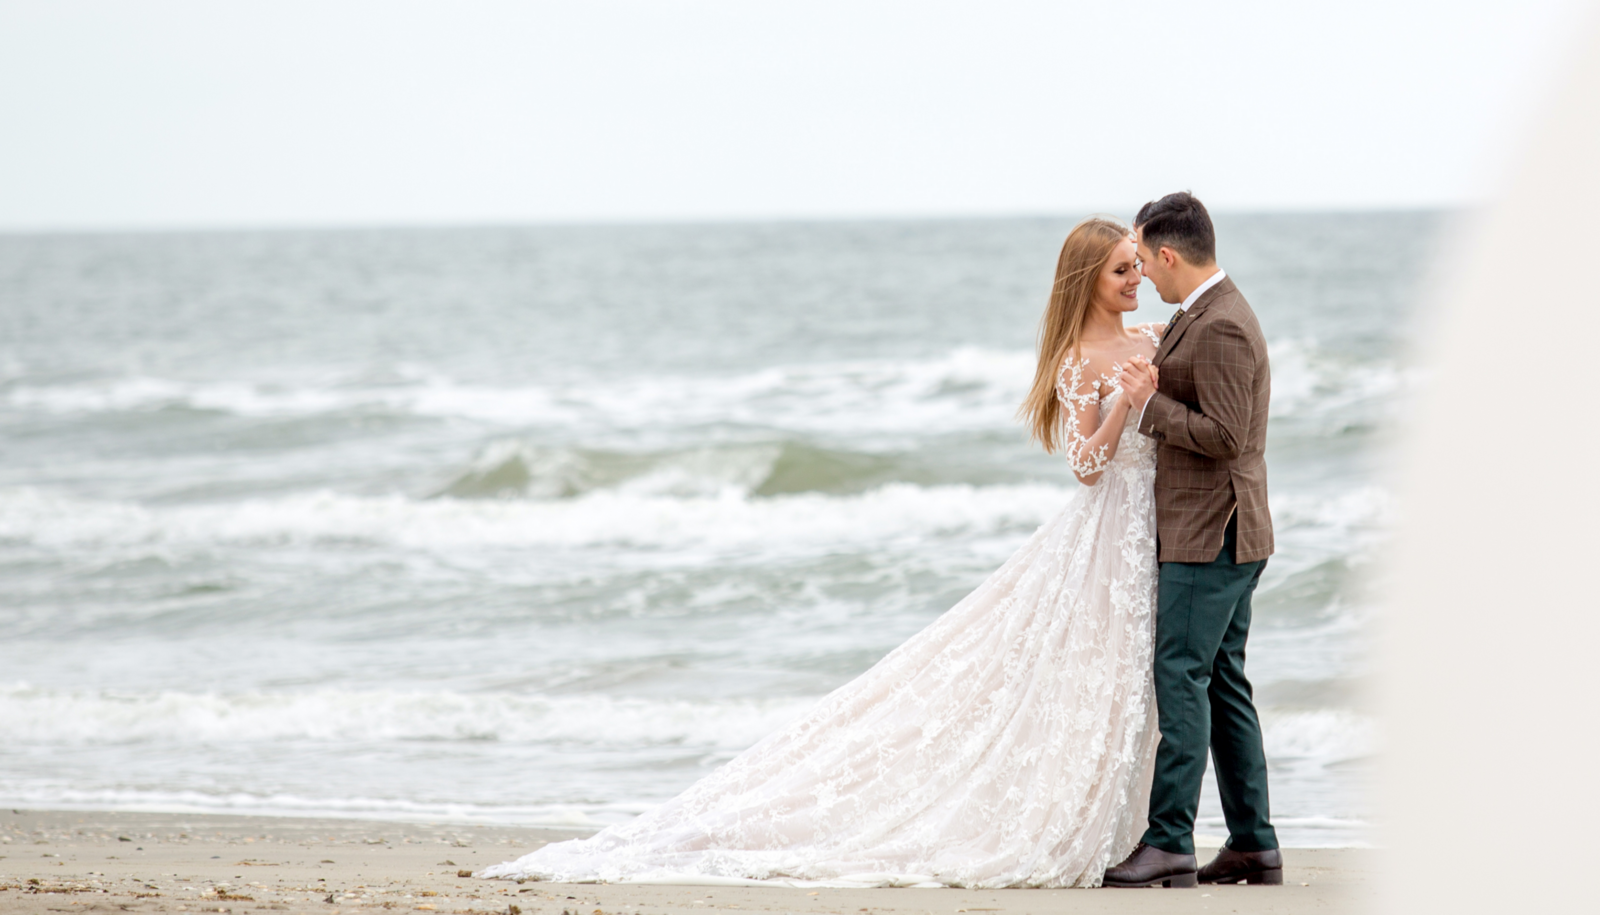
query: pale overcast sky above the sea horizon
0 0 1582 229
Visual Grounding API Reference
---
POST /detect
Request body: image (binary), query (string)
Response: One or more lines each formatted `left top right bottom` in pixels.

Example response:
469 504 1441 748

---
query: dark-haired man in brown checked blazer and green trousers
1106 194 1283 886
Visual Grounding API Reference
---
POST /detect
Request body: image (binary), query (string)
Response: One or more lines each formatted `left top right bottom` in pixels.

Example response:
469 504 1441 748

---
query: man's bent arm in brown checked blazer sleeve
1139 322 1256 459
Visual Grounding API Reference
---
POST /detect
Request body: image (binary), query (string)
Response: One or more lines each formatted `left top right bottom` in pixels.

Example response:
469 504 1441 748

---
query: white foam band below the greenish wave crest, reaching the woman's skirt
0 483 1072 550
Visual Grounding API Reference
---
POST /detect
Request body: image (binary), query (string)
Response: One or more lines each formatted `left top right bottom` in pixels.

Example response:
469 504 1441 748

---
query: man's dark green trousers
1144 521 1278 854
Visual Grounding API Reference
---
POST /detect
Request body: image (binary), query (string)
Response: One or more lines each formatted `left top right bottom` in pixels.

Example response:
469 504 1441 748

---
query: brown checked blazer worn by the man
1139 277 1274 563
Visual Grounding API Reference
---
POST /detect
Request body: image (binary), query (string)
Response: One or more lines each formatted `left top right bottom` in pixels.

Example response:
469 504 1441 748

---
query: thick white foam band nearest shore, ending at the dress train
0 685 814 752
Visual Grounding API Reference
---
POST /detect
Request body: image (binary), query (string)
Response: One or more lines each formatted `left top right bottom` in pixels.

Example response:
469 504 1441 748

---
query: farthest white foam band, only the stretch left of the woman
3 347 1032 434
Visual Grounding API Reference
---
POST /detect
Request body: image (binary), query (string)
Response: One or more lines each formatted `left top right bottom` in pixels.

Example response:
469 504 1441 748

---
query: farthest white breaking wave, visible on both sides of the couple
0 339 1419 434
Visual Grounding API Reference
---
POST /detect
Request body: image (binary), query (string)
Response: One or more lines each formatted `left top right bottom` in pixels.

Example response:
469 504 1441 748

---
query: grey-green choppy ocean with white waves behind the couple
0 213 1427 846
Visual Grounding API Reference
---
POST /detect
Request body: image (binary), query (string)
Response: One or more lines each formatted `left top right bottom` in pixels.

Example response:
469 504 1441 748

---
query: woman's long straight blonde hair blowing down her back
1018 216 1131 453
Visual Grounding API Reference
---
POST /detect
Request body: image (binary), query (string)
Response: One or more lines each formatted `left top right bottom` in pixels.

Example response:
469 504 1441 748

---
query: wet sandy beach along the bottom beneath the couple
0 809 1378 915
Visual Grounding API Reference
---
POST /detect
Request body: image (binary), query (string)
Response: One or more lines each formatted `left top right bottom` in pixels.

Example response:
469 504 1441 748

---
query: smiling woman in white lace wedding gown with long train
478 219 1160 888
